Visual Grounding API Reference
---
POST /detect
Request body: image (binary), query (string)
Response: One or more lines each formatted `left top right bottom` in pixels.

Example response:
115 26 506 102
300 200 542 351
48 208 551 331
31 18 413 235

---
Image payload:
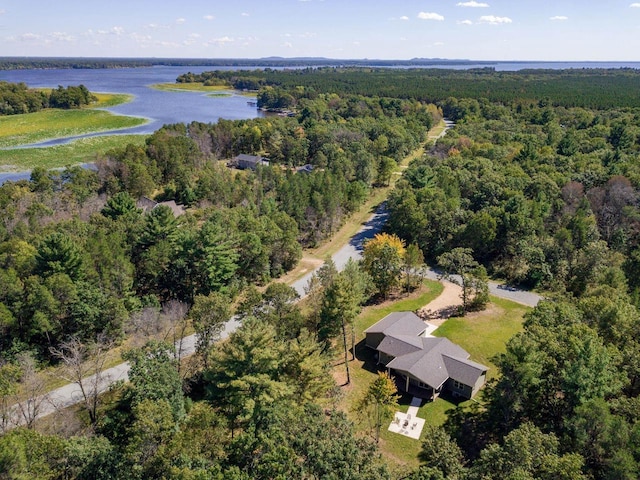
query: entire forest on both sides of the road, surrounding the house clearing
0 65 640 480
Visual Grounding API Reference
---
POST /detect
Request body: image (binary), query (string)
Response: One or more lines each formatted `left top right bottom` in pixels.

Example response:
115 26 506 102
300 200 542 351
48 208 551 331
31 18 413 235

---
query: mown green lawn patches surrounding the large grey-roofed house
335 288 529 470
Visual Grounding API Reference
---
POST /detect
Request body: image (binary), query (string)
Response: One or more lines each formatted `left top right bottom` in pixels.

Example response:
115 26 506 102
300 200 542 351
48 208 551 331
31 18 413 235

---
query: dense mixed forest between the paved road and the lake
0 86 438 361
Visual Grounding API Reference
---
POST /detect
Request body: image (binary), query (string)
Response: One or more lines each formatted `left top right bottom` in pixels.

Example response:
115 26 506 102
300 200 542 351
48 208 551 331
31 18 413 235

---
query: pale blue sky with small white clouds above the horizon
0 0 640 61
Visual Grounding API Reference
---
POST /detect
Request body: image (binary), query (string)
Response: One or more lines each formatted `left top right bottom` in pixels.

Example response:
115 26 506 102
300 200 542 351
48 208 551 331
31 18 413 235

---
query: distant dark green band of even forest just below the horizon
178 66 640 109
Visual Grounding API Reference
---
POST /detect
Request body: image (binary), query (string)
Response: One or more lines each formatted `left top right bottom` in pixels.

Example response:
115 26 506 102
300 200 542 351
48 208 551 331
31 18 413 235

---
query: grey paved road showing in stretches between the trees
6 116 542 423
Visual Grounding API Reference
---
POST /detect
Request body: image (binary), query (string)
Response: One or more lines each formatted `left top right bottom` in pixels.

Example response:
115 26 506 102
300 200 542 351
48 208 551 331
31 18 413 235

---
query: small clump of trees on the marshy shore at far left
0 81 97 115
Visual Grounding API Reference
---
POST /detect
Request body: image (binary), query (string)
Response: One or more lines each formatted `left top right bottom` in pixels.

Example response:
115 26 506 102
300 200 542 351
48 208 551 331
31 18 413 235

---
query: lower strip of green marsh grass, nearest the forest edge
0 135 146 172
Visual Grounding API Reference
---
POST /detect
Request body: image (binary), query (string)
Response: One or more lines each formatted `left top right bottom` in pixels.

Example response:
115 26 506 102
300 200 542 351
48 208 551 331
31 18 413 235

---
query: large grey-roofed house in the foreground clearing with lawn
365 312 488 400
